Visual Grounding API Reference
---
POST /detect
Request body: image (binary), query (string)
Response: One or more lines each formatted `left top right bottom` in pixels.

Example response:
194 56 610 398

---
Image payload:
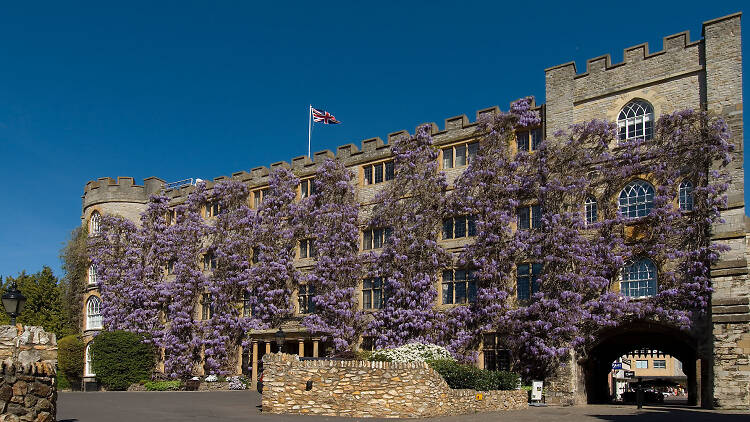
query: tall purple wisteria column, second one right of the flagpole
368 125 451 347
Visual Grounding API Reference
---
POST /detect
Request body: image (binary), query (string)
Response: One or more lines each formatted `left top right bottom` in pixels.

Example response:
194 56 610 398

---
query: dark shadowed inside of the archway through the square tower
579 322 710 406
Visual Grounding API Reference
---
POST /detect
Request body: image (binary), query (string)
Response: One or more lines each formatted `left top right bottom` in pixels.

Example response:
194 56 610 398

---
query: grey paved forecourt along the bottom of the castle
57 391 750 422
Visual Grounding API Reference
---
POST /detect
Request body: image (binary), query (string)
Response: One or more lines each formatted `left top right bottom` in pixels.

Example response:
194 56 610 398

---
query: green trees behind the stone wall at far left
0 266 71 338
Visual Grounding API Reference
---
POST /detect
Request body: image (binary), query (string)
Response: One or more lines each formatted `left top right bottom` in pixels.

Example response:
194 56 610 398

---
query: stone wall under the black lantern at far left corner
0 324 57 422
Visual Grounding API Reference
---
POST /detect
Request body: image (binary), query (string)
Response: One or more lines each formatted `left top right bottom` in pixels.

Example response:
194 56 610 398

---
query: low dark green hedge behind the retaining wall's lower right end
427 359 519 391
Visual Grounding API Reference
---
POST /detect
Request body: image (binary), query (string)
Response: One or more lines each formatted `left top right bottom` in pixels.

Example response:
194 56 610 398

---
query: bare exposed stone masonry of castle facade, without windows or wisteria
81 13 750 409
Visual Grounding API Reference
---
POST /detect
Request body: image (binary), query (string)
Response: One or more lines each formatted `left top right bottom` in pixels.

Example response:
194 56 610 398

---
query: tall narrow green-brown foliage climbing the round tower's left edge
60 226 90 332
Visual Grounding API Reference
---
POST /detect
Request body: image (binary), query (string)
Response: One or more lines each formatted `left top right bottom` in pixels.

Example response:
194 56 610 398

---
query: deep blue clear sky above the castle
0 1 749 276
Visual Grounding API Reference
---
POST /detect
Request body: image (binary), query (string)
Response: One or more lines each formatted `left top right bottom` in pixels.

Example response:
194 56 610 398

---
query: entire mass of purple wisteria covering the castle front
90 102 732 378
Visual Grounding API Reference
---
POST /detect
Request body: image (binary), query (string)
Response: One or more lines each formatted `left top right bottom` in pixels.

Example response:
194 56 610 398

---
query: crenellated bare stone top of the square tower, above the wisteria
545 13 741 137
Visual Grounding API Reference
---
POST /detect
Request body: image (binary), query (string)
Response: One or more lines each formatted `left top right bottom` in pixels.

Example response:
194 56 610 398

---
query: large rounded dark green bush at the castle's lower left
91 331 155 390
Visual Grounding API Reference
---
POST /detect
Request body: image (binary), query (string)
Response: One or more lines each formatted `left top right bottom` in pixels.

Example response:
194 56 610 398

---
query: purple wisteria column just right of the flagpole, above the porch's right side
301 159 364 354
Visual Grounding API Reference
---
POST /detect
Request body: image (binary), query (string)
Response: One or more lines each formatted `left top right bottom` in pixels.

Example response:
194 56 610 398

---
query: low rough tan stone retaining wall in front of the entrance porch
262 354 528 418
